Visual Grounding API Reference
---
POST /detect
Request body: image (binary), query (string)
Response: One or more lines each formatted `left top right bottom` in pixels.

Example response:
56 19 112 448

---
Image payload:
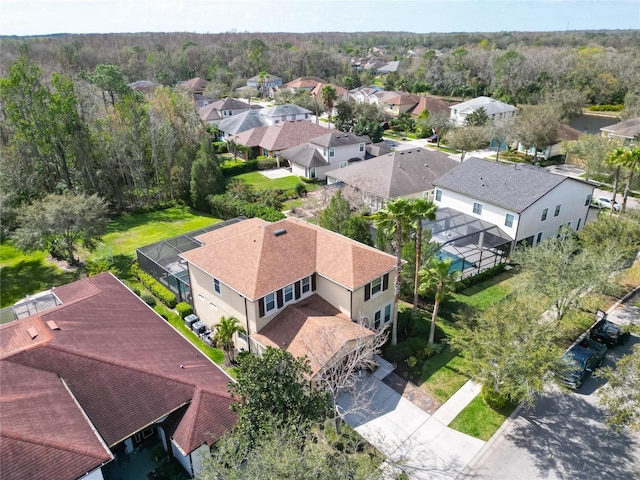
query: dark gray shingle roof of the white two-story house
433 157 568 212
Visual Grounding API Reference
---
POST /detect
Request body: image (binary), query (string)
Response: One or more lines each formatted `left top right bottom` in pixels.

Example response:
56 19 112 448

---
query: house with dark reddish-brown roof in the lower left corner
0 273 236 480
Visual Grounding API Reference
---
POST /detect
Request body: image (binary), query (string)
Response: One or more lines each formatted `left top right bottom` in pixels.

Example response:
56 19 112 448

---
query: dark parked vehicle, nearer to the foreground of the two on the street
553 338 607 390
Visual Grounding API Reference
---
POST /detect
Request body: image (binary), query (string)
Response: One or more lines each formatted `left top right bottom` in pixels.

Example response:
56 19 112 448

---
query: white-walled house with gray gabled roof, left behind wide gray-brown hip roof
279 130 371 179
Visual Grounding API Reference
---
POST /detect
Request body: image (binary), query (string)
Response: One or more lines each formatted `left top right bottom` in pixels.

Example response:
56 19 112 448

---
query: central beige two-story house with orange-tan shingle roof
181 218 395 373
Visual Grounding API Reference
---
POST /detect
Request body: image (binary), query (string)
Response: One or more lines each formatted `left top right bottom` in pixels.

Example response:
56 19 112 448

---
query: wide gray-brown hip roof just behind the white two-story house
327 148 458 199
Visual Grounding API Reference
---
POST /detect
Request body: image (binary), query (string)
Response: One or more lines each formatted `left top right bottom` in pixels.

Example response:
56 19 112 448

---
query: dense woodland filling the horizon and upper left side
0 30 640 234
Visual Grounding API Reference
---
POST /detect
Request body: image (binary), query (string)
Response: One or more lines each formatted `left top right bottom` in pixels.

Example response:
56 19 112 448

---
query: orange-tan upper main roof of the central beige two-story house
181 218 395 301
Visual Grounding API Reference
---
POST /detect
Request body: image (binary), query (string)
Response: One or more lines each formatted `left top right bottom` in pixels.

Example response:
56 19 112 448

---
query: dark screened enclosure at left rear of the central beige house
136 217 245 304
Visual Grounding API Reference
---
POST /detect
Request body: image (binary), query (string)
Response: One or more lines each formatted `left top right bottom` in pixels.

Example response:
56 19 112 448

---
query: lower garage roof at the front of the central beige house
251 294 374 376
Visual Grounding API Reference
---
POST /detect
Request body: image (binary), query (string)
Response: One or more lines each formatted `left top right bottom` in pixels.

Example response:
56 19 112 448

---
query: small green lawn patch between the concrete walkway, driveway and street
449 395 515 441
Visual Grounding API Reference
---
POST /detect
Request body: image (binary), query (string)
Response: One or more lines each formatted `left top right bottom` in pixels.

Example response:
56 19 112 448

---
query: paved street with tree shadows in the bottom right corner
465 296 640 480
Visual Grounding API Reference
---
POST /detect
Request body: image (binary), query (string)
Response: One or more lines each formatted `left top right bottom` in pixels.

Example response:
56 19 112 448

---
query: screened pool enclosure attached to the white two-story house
423 207 513 278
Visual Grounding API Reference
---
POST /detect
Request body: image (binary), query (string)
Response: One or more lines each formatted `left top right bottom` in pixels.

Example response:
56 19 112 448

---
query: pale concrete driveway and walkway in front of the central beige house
338 362 485 480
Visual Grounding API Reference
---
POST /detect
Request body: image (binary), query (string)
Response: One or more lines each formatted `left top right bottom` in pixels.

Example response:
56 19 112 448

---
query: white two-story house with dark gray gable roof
433 157 594 248
